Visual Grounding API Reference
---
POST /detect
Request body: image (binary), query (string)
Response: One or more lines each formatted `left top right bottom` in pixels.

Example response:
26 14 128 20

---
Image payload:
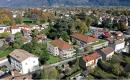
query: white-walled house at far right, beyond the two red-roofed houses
114 40 125 52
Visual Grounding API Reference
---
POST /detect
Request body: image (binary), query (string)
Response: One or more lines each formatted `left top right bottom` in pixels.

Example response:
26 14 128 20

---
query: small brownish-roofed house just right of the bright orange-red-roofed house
101 47 114 60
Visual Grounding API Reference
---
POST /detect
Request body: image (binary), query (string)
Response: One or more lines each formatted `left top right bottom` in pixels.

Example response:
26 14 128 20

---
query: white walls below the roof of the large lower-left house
10 57 39 74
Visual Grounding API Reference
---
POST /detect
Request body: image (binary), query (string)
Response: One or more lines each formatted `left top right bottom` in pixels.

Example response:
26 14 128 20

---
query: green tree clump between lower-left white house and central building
21 40 49 64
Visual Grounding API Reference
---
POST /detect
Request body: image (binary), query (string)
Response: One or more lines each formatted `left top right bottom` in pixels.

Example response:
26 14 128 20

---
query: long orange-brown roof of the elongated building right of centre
71 33 97 43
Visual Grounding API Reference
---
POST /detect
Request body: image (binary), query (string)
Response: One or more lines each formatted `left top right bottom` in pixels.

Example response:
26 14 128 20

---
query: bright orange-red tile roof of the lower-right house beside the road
83 52 100 62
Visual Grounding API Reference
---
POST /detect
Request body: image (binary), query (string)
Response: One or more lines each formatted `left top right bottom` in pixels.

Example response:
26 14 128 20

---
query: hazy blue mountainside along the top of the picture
0 0 130 7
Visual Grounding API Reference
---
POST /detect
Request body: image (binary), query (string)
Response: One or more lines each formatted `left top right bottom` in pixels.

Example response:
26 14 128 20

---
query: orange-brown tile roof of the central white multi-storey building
52 39 72 49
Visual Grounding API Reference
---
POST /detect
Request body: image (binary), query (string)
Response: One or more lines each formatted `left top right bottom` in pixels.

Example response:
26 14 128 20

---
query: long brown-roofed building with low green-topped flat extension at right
71 33 108 50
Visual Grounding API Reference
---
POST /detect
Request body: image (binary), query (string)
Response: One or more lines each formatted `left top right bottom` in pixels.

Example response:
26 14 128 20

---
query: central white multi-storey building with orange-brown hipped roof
47 39 75 58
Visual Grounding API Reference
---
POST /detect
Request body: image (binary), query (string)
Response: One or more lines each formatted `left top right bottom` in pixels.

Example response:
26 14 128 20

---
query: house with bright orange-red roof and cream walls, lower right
83 52 102 68
